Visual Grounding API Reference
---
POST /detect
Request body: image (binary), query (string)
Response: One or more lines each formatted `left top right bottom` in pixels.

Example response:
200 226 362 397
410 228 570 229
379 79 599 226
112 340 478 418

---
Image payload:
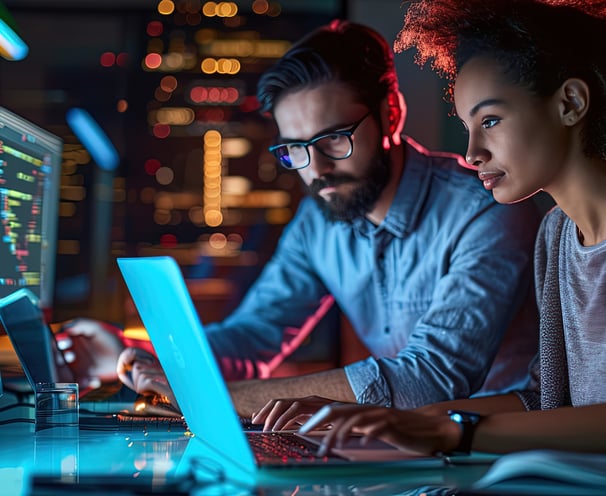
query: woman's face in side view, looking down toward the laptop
454 57 571 203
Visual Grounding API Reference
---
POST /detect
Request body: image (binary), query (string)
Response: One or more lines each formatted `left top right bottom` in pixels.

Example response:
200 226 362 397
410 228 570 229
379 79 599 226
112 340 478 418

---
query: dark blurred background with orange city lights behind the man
0 0 476 372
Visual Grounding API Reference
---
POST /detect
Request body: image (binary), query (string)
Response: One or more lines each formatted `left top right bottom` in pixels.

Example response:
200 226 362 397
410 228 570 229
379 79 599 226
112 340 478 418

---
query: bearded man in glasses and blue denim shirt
69 21 538 422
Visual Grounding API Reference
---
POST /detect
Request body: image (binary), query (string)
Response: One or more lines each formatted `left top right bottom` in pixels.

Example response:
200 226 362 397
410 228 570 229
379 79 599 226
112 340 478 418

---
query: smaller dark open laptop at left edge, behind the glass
0 288 187 432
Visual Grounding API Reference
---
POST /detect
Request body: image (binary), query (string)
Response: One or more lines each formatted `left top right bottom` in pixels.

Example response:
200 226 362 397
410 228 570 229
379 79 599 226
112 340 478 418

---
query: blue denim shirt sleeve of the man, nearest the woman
345 199 538 408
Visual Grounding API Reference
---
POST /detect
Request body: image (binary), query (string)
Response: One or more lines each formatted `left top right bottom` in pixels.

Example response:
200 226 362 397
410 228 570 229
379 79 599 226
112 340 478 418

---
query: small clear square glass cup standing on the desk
35 382 80 436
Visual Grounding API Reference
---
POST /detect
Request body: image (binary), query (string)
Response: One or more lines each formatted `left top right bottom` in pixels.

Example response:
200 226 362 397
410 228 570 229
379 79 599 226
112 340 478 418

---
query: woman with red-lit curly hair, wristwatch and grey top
301 0 606 453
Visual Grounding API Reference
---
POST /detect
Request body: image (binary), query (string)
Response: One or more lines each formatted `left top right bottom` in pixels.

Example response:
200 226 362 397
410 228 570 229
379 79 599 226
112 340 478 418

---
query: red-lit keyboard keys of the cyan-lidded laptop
248 432 342 465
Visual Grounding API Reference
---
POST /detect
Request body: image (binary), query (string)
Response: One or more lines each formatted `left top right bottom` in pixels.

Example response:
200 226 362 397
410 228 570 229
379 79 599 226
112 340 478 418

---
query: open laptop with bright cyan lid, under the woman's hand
117 256 443 474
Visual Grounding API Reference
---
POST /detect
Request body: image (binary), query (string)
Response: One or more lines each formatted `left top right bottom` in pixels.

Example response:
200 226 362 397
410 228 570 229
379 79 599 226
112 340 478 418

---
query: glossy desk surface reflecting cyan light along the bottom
0 395 606 496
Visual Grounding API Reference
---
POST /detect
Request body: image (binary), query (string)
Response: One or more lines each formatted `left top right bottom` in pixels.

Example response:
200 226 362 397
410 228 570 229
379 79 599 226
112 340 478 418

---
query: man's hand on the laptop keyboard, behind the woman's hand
252 396 346 431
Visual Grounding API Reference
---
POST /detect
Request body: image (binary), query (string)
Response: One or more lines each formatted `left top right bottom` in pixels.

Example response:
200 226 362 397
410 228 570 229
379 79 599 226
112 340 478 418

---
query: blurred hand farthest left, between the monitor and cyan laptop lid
55 318 124 394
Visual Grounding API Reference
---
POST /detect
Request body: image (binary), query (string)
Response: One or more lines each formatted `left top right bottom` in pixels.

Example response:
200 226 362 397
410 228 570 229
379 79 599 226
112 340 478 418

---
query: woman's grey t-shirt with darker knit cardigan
517 206 606 410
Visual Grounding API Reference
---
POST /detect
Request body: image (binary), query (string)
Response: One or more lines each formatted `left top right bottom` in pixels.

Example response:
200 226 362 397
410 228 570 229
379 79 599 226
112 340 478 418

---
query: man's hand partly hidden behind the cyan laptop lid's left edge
117 348 178 408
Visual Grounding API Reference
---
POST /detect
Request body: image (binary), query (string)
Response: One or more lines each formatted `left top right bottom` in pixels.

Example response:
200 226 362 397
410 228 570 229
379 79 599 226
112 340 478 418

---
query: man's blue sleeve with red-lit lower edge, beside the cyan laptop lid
206 200 334 380
